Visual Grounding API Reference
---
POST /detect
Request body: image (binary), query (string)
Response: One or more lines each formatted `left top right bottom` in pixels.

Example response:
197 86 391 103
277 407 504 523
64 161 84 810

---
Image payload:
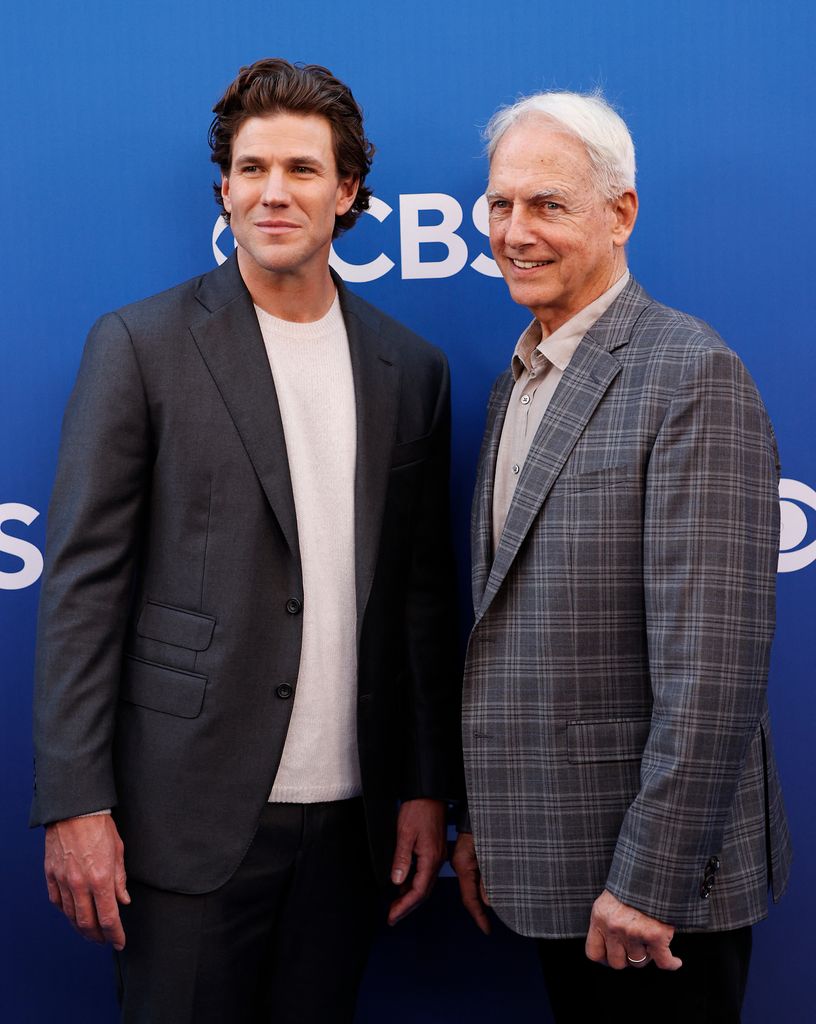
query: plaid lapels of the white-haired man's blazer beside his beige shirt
474 279 651 622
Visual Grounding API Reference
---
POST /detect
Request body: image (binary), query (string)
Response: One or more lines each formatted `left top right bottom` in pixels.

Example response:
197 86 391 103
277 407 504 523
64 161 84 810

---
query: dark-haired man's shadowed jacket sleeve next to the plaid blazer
400 354 464 800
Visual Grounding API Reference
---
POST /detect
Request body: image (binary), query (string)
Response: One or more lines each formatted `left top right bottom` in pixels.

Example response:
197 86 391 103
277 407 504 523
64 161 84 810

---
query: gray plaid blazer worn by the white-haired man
463 280 790 937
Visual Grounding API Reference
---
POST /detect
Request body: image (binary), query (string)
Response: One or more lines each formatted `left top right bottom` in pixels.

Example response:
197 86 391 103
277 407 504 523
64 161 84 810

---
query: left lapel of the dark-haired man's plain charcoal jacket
190 256 300 558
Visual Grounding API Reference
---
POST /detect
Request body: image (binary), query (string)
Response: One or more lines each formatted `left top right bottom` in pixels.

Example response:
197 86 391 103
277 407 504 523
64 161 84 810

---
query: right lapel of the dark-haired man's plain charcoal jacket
333 275 400 639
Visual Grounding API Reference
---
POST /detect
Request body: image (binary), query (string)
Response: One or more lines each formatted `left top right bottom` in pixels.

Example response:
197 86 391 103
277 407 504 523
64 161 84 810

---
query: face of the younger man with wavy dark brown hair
221 113 357 283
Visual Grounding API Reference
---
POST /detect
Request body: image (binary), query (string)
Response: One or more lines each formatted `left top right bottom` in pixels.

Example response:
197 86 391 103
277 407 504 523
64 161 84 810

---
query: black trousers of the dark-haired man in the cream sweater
117 799 380 1024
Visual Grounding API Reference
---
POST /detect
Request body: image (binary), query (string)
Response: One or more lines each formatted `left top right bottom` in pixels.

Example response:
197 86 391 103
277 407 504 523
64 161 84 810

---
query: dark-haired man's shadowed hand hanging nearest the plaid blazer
388 800 447 925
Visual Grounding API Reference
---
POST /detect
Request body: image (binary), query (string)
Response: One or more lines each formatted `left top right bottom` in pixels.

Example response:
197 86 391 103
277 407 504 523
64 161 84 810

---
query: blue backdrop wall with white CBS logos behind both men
0 0 816 1024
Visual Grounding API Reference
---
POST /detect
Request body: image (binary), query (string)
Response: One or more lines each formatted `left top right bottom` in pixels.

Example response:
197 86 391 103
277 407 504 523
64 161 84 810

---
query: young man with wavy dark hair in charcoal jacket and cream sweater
32 59 457 1024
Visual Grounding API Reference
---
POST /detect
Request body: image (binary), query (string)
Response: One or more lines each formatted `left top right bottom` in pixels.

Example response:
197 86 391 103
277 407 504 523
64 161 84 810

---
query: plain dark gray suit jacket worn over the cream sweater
32 258 458 892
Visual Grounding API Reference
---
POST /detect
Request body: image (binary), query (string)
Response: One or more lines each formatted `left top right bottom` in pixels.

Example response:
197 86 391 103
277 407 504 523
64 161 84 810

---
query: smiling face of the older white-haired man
487 116 637 334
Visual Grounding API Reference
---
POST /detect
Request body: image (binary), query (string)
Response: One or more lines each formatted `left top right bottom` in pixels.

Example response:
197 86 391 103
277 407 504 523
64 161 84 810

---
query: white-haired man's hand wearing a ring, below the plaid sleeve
586 889 683 971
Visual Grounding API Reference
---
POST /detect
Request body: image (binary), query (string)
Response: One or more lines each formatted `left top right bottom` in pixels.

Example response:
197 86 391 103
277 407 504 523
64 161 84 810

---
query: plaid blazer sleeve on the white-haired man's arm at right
607 348 779 927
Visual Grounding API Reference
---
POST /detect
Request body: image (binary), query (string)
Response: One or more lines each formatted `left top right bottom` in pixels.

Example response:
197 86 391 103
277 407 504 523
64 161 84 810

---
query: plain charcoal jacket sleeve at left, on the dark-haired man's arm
31 314 152 825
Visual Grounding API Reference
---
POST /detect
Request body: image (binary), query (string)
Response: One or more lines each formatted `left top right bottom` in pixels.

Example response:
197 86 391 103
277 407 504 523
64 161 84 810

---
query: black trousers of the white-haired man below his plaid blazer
536 928 751 1024
